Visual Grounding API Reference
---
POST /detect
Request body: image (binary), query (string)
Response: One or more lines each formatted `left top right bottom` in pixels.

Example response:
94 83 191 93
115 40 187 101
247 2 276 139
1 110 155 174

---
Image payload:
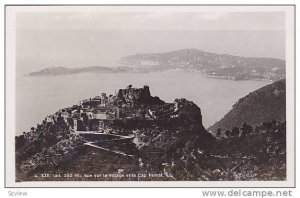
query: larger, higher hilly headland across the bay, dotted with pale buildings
120 49 285 80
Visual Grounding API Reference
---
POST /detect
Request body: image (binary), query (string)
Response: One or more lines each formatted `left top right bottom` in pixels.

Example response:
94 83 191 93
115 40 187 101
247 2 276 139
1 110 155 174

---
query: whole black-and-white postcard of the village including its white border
5 5 295 187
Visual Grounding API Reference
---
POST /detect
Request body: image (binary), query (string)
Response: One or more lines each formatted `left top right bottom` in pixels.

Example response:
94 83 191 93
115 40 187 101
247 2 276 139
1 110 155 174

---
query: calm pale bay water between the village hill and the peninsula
16 72 270 135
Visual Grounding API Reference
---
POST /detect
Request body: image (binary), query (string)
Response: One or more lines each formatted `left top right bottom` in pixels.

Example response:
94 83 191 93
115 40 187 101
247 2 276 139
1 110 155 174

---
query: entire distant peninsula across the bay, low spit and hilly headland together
27 49 285 81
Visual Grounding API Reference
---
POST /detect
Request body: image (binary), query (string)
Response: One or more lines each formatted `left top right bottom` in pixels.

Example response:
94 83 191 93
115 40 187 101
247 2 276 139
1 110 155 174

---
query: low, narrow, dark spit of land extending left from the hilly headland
28 66 131 76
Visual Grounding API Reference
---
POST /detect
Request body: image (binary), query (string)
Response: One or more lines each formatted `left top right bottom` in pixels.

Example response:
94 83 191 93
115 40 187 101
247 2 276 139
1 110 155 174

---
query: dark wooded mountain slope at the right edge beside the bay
208 79 286 133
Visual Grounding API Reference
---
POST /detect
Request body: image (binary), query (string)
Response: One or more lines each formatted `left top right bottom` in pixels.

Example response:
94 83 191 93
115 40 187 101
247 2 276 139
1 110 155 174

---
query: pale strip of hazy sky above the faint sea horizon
17 11 285 30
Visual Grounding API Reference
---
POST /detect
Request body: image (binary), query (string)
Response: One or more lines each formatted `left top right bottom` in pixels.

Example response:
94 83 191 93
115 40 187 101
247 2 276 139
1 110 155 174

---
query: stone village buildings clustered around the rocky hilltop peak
40 85 184 135
